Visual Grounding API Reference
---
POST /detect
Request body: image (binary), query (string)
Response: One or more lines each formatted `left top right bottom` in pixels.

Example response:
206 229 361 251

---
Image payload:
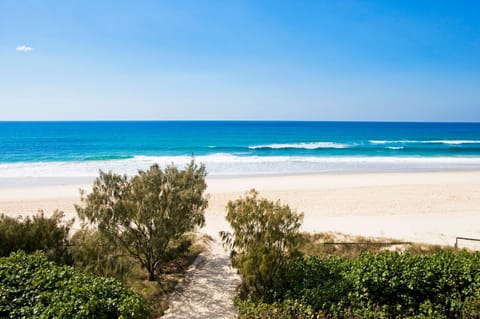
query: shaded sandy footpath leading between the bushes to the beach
161 239 240 319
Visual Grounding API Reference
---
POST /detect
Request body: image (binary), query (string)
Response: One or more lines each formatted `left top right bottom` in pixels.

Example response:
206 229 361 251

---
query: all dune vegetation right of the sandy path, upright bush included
222 191 480 318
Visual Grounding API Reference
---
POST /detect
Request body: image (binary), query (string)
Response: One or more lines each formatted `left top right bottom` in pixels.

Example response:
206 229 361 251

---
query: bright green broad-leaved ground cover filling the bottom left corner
0 252 149 319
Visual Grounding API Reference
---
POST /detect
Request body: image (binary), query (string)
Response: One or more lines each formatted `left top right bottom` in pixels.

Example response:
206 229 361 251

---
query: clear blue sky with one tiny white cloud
0 0 480 122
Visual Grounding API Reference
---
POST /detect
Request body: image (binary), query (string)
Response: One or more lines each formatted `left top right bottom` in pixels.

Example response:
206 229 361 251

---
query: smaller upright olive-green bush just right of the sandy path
221 190 303 298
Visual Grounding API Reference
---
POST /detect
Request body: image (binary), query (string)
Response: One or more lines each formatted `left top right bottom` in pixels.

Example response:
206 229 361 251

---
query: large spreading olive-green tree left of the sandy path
76 160 208 280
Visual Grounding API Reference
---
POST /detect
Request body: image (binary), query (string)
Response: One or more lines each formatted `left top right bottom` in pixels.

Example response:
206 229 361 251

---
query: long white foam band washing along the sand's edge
0 153 480 178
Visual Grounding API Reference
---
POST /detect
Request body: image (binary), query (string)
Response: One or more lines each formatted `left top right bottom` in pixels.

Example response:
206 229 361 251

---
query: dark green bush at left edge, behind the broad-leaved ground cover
0 211 73 263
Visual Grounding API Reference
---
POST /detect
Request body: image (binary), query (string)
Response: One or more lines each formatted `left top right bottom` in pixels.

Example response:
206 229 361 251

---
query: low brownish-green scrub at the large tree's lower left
70 228 133 282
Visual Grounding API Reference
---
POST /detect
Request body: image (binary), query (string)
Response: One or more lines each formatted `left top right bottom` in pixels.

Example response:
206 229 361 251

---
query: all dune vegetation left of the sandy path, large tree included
0 161 207 318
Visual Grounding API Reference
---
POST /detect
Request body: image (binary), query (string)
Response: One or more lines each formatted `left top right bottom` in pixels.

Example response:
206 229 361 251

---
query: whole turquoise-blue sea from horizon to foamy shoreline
0 121 480 185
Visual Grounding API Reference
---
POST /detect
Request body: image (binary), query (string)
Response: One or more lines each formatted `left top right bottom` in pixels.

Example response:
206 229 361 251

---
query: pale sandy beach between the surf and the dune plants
0 171 480 245
